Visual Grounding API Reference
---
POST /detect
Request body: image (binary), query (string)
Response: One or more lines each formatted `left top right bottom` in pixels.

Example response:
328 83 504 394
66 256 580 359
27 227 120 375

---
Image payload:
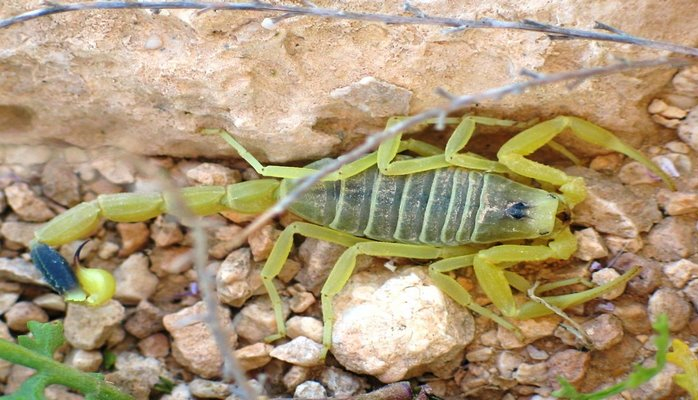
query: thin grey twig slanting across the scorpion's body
240 58 691 241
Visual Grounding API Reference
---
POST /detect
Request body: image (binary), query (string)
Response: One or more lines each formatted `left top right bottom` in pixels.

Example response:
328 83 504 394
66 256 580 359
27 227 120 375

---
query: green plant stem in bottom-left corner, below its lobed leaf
0 339 133 400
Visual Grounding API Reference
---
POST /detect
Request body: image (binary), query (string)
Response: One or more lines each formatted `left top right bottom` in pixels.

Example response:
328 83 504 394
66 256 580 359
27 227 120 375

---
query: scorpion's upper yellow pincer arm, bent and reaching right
497 116 674 206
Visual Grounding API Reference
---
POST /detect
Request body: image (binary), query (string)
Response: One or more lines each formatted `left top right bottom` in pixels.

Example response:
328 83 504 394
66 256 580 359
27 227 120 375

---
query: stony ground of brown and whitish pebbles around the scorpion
0 68 698 399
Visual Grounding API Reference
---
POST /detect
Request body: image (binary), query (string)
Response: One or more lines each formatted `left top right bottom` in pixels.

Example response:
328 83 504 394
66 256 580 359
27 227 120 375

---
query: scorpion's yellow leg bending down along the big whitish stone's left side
320 241 472 353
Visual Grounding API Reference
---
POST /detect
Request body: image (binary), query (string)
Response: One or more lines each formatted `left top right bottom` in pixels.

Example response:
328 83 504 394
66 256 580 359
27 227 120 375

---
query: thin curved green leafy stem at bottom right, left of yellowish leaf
553 314 669 400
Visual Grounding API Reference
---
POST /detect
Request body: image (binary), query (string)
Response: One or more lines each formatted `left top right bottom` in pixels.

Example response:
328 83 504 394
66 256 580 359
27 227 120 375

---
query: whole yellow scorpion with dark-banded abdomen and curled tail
31 116 673 356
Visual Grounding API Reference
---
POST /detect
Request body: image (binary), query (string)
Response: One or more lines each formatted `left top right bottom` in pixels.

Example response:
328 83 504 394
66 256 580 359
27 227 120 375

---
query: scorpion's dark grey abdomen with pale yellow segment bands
287 160 484 246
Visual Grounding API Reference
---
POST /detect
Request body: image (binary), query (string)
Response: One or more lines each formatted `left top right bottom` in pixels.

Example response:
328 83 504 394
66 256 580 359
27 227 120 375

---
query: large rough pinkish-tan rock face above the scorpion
0 0 698 162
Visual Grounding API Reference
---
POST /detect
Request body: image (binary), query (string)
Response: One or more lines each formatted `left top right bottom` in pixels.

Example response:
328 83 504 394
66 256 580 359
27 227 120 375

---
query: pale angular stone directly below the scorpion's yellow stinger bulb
63 300 125 350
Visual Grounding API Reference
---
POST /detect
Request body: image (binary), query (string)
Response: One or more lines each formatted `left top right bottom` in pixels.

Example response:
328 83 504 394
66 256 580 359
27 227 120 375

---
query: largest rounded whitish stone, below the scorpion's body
331 268 474 382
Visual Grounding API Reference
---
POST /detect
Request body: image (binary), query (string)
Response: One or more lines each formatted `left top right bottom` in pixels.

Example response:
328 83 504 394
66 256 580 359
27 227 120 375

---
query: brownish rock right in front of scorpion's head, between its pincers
566 167 661 238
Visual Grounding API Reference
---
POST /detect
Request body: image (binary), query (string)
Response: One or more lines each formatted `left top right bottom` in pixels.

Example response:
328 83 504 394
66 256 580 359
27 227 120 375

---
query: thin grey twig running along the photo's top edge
0 1 698 56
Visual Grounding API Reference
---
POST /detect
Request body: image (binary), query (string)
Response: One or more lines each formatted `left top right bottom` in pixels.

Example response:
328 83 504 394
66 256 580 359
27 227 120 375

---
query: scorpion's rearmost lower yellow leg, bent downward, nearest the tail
261 222 367 341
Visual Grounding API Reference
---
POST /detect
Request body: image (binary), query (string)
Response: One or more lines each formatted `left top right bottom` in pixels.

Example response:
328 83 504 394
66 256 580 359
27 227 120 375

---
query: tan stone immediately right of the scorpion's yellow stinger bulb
114 253 158 304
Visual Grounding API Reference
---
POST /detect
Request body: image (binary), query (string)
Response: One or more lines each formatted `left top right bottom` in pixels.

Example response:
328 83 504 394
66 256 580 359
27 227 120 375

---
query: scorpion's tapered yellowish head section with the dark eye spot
472 175 571 243
